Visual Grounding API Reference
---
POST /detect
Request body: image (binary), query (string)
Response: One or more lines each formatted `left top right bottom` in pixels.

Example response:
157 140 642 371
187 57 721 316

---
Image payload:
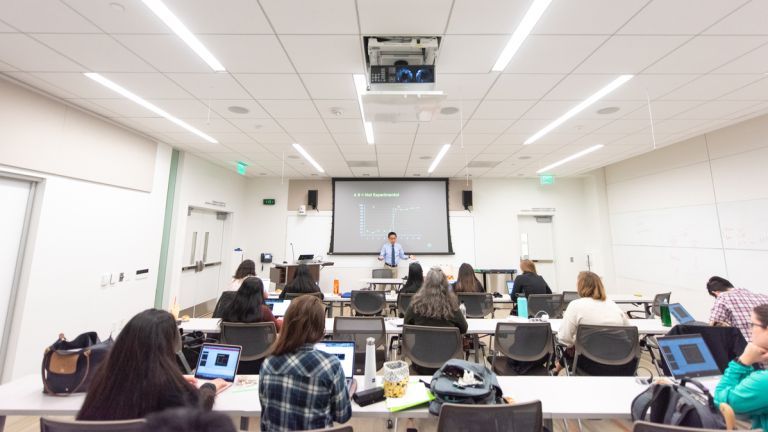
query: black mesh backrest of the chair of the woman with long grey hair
402 325 464 369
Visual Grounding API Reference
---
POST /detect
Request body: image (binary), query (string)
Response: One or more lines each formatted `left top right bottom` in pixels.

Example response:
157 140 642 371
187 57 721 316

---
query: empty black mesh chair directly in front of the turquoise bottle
488 322 555 375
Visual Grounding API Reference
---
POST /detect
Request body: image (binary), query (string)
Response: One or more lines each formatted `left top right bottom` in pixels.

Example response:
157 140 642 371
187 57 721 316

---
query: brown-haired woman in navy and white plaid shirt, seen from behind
259 296 352 431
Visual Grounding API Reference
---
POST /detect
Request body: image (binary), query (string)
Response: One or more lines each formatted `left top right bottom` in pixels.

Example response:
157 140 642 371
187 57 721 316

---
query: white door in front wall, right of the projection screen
517 215 559 291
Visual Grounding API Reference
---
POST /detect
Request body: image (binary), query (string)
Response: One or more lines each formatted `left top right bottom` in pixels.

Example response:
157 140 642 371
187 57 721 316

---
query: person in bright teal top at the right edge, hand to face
715 304 768 430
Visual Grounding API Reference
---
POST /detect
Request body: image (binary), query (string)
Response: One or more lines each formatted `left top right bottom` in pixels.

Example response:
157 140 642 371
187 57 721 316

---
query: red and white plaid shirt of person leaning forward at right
709 288 768 342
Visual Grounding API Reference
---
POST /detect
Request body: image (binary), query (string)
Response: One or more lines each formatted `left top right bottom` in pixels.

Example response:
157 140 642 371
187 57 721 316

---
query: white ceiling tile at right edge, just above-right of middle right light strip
644 36 768 73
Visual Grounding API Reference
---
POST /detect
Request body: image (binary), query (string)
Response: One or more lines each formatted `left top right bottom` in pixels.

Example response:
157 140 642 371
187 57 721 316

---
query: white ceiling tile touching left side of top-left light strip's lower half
114 34 211 73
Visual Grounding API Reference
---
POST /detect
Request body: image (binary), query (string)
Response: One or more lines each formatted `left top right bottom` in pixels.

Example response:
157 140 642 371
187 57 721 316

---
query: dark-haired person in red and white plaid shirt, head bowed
707 276 768 342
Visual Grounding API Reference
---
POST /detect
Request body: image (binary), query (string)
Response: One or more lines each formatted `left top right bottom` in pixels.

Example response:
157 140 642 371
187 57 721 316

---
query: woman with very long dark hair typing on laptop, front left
77 309 228 420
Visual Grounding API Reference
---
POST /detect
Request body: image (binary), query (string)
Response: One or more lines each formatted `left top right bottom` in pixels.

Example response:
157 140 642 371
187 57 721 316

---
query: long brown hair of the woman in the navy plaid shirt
270 296 325 355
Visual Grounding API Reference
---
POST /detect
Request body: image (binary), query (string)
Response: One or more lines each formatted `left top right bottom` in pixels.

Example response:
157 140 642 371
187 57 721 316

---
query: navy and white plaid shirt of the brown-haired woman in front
259 344 352 431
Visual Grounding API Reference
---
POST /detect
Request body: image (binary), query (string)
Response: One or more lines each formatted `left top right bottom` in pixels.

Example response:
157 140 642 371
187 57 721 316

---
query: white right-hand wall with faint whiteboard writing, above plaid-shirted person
605 113 768 321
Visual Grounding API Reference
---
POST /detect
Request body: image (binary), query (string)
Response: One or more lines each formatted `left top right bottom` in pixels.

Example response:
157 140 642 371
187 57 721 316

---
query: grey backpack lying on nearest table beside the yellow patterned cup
429 359 504 415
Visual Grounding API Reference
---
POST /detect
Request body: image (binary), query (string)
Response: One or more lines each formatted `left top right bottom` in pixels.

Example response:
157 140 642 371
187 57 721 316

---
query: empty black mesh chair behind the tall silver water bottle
333 317 387 375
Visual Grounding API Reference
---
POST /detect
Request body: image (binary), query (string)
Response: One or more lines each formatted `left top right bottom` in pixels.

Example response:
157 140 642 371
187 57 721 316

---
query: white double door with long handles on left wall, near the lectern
178 207 227 317
